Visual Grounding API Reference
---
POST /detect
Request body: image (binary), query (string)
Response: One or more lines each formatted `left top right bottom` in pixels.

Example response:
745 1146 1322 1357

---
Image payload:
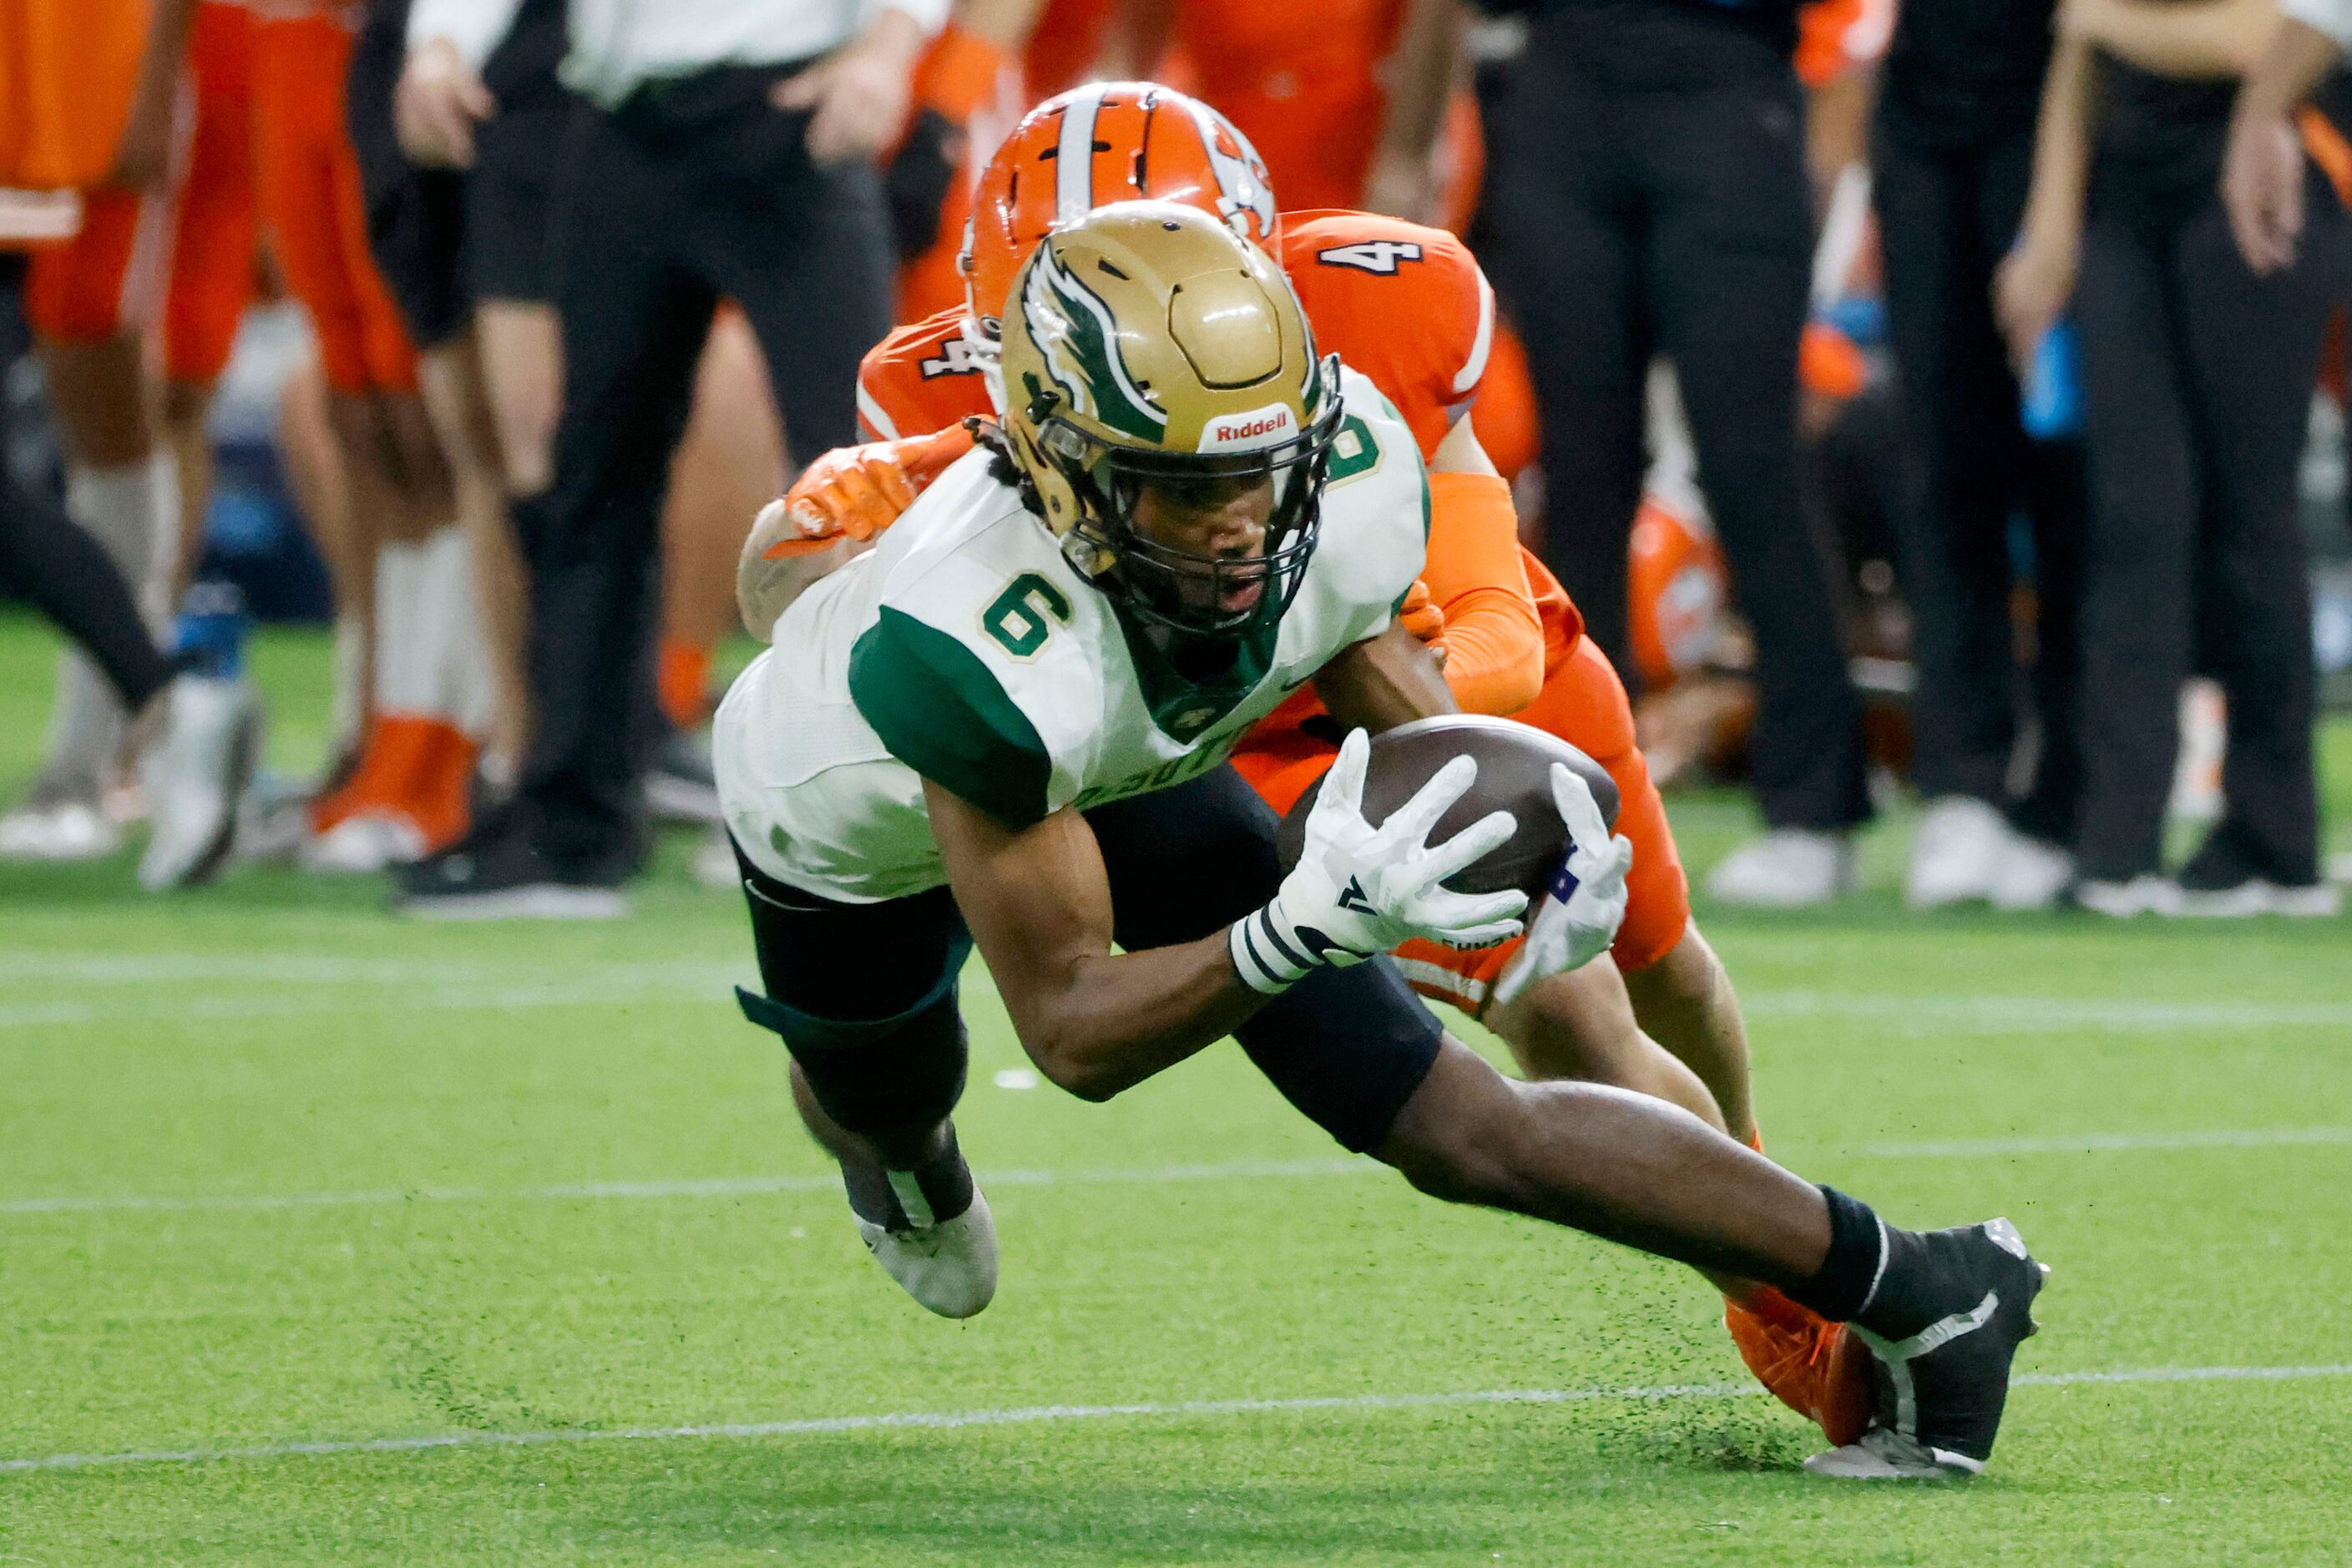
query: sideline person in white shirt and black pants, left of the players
400 0 948 917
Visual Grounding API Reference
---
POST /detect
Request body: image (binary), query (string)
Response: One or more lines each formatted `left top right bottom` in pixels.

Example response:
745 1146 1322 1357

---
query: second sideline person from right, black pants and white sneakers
1872 0 2084 910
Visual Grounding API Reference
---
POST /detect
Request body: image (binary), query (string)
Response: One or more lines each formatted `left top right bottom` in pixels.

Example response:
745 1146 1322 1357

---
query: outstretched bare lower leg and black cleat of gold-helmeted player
1371 1039 2046 1476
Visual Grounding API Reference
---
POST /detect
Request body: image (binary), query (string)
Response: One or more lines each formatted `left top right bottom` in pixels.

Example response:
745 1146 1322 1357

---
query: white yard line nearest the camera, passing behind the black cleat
0 1366 2352 1474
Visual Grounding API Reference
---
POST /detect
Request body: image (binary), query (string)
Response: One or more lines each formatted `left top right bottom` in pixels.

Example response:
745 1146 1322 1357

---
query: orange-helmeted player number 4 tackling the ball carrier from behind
739 84 1868 1444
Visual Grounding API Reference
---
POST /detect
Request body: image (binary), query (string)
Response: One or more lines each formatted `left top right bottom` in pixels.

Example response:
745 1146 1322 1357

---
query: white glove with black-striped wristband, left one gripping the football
1226 729 1526 997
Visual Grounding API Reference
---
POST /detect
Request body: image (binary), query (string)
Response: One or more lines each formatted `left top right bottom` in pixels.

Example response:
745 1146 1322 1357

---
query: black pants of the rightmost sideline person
2075 179 2347 884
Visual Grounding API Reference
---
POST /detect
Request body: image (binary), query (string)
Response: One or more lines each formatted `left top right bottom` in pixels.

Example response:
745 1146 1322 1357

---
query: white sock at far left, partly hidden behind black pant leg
35 452 179 797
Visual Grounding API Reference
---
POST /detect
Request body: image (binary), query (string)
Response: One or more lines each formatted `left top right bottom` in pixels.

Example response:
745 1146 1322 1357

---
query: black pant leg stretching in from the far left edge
0 259 172 712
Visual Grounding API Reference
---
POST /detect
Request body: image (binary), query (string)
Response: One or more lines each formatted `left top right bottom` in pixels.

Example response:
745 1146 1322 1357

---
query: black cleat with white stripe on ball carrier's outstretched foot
1804 1220 2049 1481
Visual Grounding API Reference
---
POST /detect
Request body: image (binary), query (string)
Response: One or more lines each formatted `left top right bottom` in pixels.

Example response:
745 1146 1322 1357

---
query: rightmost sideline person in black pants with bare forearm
1999 0 2352 914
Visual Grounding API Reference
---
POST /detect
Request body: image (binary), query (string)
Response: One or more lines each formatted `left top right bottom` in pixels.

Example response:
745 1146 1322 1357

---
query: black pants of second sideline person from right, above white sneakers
1872 124 2086 844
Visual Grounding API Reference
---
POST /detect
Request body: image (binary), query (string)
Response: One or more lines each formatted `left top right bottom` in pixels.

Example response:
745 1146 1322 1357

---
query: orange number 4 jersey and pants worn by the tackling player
858 211 1691 987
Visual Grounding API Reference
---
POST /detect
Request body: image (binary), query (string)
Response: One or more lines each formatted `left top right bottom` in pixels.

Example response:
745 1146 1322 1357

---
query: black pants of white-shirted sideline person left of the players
515 68 892 873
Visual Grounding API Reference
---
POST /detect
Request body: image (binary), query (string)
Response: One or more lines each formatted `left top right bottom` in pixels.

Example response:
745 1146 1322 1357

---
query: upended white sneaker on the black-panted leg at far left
139 675 261 891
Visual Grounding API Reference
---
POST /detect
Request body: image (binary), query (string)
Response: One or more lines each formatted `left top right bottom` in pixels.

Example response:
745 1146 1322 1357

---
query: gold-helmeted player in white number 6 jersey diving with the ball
717 202 2041 1474
